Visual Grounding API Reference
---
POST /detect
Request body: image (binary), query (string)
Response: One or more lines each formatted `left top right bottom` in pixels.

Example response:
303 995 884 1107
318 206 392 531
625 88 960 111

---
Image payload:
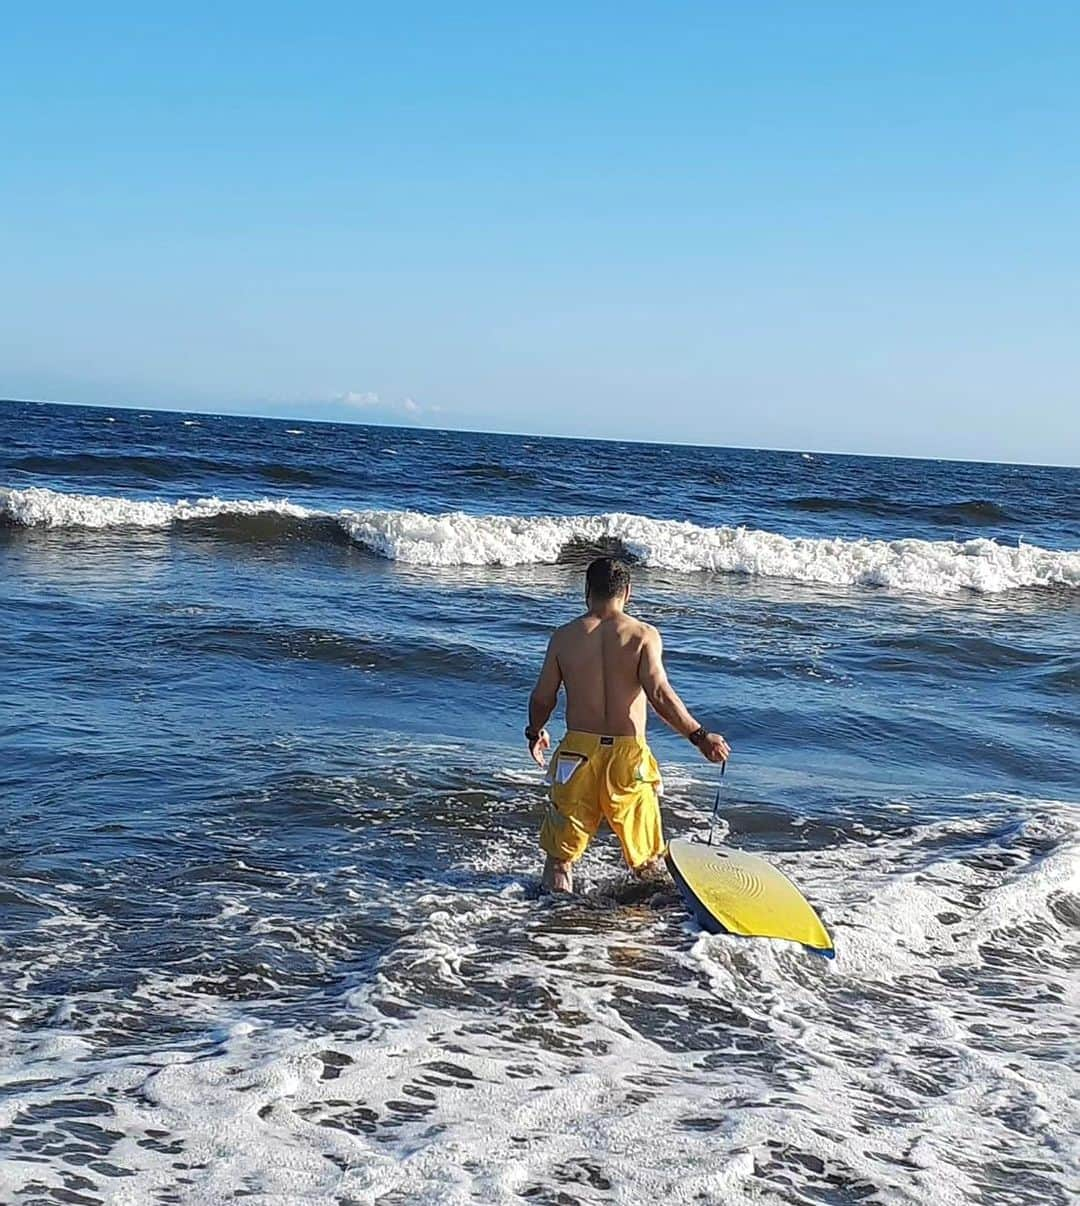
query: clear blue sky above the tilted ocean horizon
0 0 1080 464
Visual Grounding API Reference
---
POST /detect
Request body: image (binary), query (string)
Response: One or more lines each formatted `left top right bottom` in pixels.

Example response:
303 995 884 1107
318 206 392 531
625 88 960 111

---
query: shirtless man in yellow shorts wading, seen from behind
526 557 730 892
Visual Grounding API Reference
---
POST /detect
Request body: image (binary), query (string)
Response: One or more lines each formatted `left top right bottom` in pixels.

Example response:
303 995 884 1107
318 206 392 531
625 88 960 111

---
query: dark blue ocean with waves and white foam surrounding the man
0 403 1080 1206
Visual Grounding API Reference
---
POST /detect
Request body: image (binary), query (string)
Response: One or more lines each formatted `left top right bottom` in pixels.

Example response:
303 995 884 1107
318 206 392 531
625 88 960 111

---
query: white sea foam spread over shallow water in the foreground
0 801 1080 1206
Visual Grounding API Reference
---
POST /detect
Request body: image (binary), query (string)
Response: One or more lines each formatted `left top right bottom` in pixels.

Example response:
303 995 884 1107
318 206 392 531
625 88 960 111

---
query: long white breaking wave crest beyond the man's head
0 487 1080 595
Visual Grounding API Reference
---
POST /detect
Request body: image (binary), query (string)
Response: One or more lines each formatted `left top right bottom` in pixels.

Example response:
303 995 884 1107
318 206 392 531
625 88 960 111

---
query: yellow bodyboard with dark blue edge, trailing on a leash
668 838 834 958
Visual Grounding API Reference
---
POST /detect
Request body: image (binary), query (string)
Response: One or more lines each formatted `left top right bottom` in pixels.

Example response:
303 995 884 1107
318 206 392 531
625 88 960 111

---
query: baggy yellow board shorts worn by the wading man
540 731 664 870
